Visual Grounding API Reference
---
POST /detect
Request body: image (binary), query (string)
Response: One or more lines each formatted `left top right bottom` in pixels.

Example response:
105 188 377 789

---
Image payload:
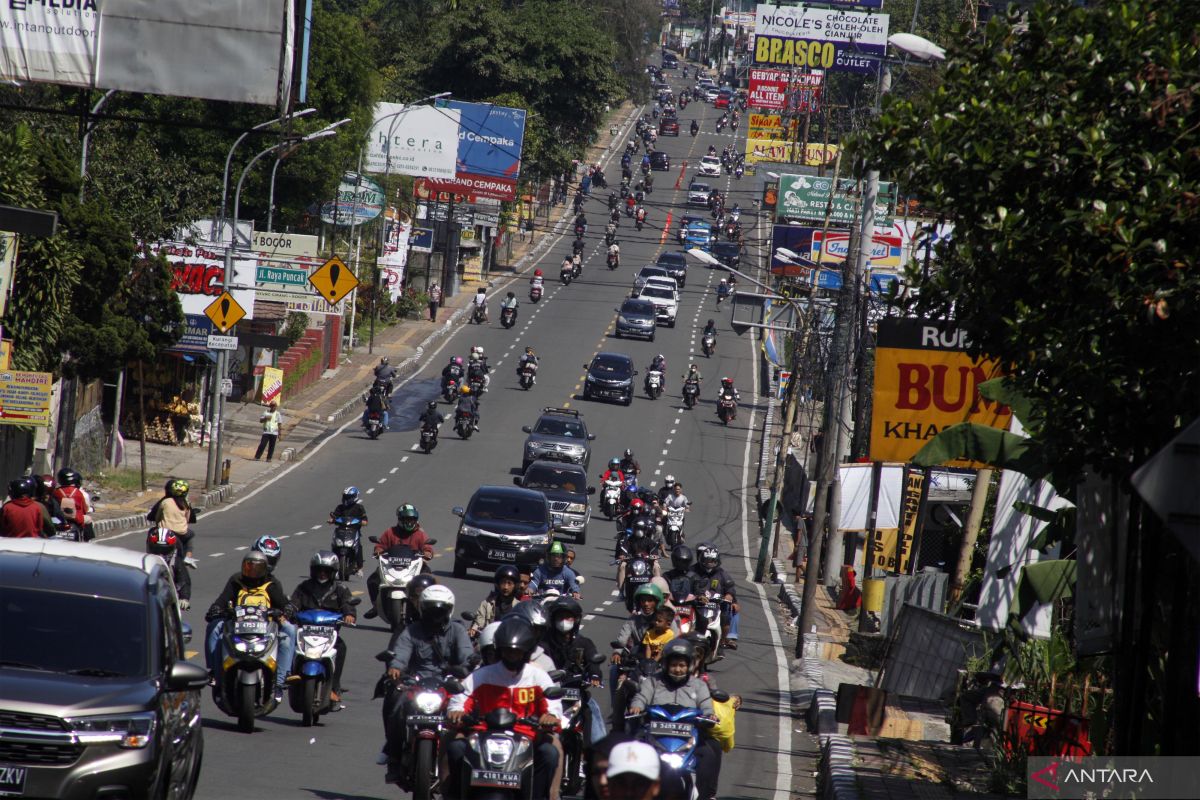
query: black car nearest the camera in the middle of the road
452 486 553 578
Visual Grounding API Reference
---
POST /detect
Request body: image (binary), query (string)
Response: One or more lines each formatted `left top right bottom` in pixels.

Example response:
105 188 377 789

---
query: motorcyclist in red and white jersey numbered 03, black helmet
443 618 565 800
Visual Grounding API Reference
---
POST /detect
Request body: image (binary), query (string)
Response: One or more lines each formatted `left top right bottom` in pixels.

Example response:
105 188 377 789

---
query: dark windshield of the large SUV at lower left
0 585 150 678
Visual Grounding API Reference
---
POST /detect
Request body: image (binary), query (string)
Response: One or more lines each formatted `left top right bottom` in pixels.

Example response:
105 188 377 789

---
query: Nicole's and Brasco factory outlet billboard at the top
754 4 888 72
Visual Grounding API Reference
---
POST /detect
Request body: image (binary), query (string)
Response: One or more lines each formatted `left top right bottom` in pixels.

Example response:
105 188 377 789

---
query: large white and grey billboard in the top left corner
0 0 295 107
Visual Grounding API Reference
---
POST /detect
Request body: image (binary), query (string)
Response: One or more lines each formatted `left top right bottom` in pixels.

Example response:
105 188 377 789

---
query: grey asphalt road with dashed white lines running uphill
105 68 793 800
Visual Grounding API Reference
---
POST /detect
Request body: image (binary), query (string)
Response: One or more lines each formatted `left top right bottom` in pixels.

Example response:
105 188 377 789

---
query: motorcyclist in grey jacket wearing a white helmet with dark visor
383 585 475 783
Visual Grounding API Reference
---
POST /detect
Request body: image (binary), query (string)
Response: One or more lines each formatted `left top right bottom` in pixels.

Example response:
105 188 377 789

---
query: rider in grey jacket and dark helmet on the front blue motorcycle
629 638 721 800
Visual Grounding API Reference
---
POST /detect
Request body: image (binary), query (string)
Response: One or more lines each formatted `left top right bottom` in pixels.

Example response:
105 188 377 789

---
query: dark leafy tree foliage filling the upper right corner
860 0 1200 474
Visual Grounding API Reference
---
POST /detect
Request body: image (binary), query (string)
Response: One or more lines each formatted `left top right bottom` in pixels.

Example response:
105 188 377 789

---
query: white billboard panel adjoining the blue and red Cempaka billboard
364 103 458 178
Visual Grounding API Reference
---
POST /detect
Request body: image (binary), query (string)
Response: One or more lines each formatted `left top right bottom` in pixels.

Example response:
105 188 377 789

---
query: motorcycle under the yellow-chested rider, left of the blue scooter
212 606 283 733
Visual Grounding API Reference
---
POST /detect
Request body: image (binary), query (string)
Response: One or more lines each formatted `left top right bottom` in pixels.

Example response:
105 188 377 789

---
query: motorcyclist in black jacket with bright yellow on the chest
204 551 296 704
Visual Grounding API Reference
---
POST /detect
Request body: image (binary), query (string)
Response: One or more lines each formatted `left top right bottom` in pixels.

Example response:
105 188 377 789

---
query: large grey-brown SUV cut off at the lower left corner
0 539 208 800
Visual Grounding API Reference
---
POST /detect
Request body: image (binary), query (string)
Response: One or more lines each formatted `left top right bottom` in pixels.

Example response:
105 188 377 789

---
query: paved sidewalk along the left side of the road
95 103 636 535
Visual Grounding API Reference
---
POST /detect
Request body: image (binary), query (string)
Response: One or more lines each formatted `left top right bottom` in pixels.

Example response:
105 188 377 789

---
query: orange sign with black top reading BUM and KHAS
870 317 1013 467
